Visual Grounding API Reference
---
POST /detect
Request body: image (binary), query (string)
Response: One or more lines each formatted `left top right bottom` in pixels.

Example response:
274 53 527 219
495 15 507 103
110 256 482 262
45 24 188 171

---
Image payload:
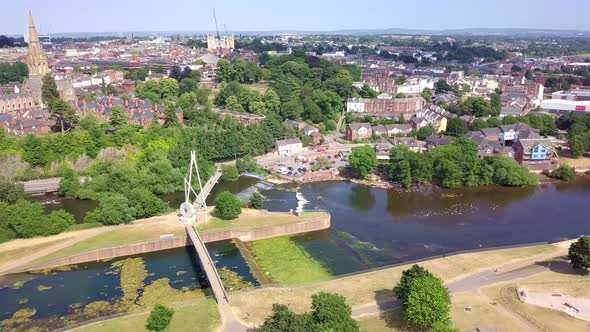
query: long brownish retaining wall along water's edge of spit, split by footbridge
26 217 330 269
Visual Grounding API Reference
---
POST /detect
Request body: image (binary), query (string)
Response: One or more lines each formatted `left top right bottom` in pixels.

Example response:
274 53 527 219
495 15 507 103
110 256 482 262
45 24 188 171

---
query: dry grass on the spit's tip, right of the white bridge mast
197 209 329 232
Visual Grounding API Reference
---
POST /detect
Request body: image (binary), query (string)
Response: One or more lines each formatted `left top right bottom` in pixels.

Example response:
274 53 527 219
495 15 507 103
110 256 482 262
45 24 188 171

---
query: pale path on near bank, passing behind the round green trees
352 249 569 319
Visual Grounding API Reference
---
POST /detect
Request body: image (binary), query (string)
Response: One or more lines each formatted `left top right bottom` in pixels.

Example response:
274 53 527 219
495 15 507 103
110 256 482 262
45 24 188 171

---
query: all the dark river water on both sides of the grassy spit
8 176 590 328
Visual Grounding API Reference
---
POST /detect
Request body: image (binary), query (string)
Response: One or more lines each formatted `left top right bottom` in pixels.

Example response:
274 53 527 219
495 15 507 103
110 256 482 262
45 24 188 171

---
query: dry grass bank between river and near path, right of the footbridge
232 245 559 324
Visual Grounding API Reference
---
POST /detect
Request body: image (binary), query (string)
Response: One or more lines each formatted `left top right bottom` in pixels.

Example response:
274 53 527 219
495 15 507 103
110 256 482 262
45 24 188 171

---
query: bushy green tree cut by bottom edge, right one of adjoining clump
311 292 359 332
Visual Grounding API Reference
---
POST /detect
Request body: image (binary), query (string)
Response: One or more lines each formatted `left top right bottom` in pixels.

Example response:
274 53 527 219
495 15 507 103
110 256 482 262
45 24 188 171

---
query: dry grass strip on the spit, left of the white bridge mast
31 223 186 265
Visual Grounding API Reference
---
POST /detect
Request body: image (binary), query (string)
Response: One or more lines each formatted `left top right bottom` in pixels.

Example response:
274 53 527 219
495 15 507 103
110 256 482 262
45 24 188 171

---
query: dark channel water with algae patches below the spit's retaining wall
0 241 257 330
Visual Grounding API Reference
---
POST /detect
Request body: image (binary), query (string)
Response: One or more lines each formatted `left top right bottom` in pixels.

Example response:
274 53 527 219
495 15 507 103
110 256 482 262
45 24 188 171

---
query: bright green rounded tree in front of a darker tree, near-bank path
403 276 451 330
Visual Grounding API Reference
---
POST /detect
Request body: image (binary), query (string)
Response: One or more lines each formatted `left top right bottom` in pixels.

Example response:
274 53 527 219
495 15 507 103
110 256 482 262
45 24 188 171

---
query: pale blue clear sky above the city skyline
0 0 590 34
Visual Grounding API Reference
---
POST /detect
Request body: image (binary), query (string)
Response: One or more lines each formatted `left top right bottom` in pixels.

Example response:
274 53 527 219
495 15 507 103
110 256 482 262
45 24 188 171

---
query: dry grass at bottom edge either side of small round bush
73 299 221 332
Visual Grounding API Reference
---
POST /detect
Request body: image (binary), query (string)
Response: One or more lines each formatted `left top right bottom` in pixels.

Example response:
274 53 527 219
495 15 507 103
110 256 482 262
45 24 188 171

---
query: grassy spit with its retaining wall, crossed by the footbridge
0 209 330 272
